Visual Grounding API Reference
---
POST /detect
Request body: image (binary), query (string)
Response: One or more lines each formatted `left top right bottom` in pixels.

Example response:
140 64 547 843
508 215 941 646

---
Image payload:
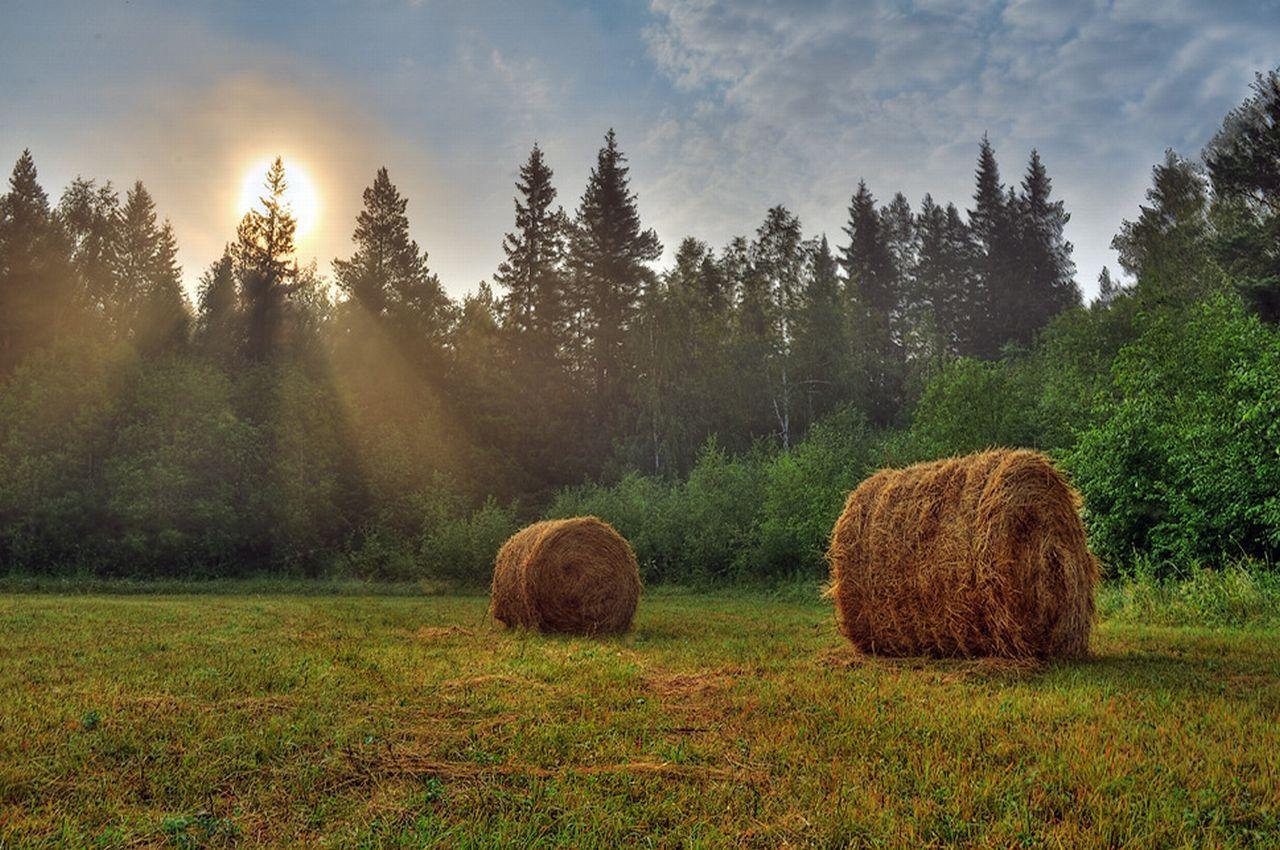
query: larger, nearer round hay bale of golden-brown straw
827 449 1098 658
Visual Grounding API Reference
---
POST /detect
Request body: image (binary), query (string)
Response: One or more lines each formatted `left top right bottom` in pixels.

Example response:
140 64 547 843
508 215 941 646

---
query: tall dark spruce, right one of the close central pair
570 129 662 425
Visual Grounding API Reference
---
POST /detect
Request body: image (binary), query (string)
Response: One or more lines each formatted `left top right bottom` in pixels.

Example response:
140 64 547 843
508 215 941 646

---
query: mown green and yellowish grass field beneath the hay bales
0 593 1280 847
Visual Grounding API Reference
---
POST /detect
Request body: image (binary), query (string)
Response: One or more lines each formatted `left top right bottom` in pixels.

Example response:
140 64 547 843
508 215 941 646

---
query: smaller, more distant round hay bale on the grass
490 516 640 635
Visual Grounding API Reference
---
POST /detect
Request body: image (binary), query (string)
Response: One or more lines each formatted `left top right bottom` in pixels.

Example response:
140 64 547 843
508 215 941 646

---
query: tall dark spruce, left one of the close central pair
494 145 568 361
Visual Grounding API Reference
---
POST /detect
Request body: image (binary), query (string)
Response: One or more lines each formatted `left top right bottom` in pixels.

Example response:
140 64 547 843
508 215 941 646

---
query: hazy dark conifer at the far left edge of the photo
0 150 76 379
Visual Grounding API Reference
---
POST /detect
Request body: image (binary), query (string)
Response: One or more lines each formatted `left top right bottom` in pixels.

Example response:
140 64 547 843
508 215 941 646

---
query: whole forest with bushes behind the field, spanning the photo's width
0 72 1280 584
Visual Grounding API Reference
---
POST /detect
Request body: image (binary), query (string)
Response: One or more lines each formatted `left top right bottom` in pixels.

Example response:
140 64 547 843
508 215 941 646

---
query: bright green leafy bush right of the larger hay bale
1066 296 1280 575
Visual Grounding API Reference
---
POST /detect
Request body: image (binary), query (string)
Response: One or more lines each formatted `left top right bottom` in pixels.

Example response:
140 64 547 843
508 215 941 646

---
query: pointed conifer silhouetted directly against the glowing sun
233 156 297 362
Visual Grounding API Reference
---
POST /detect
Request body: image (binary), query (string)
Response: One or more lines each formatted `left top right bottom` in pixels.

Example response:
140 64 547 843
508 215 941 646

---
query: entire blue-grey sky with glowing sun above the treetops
0 0 1280 302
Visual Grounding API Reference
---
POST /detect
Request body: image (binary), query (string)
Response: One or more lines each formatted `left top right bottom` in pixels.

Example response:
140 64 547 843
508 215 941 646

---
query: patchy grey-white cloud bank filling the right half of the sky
646 0 1280 298
